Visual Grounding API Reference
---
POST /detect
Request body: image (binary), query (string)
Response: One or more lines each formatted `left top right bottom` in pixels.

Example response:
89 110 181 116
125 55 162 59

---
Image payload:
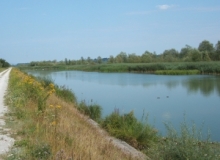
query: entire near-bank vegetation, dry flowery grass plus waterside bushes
3 69 220 160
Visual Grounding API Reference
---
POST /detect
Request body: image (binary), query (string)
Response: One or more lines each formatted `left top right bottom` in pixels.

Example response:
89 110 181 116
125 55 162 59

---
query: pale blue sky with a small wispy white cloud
0 0 220 64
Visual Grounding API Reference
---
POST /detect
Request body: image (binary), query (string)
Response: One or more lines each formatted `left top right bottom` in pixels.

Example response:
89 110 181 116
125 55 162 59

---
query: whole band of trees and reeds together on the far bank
18 40 220 74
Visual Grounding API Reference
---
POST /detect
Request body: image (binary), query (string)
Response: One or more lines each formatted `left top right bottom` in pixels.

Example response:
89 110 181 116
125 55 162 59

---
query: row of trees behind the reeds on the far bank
30 40 220 66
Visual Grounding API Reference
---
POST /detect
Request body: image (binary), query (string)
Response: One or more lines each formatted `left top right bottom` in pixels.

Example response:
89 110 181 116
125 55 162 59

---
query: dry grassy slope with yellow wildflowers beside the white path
4 69 134 160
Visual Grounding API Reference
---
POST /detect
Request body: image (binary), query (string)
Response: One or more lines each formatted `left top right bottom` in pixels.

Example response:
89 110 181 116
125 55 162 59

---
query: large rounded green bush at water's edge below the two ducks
101 111 158 150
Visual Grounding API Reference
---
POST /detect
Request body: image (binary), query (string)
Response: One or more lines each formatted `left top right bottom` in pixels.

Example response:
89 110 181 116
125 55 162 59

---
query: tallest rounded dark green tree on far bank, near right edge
198 40 215 60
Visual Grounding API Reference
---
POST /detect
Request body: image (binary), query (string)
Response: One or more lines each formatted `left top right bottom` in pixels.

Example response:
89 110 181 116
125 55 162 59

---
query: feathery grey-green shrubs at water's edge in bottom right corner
148 120 220 160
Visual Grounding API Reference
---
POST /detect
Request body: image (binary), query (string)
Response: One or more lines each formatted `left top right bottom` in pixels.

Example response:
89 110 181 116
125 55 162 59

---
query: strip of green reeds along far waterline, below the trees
18 61 220 74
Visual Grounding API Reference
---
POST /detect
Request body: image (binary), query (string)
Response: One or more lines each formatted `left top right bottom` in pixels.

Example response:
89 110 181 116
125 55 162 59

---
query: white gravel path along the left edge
0 68 14 155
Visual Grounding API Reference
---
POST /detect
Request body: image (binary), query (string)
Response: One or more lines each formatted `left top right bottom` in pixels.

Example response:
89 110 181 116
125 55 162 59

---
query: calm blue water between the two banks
29 71 220 142
